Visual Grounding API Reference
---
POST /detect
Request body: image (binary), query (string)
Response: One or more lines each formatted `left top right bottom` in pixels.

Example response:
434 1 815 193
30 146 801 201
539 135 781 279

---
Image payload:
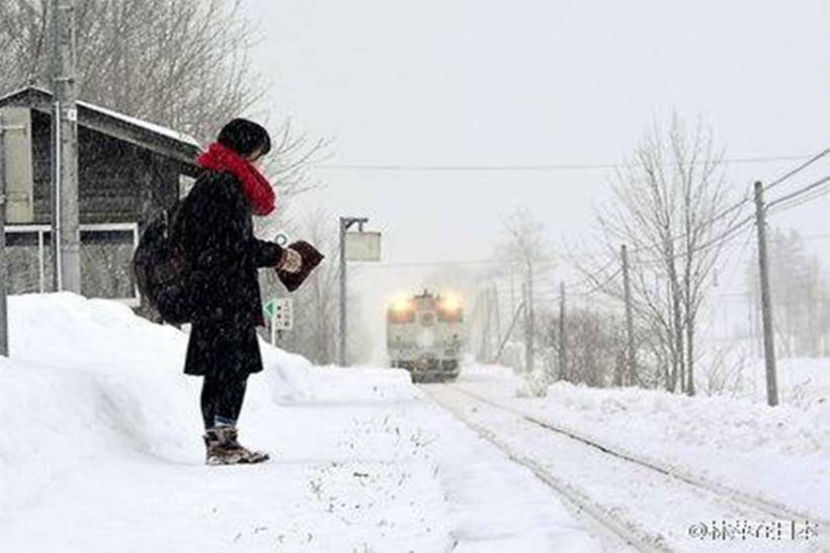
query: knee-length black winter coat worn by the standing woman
181 171 282 378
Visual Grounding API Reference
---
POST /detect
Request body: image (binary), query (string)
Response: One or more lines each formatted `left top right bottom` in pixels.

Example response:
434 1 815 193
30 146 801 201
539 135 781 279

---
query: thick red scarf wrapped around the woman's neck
196 142 277 215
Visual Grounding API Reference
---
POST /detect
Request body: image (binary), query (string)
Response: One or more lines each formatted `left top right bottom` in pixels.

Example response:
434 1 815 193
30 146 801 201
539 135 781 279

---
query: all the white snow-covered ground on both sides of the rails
0 293 830 553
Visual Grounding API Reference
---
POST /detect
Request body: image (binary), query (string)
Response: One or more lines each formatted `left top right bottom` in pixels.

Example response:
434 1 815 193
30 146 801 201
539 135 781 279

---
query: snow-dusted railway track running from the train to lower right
424 384 830 553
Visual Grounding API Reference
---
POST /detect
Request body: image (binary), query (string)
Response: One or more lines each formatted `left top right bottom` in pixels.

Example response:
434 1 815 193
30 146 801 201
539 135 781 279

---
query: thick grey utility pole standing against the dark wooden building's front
50 0 81 294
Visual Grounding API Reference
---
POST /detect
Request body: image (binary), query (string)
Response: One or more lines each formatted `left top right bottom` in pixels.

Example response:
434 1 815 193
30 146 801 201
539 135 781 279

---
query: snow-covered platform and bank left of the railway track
0 293 601 553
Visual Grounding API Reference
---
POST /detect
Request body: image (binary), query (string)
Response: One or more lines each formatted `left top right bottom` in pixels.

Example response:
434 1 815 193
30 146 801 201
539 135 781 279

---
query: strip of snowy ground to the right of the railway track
458 361 830 520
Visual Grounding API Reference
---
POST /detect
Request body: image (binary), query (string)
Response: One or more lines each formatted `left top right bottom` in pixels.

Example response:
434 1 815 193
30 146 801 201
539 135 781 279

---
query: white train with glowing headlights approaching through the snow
386 290 464 382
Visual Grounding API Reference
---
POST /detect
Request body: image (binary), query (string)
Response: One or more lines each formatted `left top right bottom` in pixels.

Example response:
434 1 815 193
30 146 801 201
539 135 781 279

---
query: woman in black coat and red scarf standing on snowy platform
181 119 302 465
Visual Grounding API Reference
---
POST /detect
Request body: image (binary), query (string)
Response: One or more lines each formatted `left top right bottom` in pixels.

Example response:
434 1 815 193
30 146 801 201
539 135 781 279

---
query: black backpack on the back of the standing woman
132 200 194 325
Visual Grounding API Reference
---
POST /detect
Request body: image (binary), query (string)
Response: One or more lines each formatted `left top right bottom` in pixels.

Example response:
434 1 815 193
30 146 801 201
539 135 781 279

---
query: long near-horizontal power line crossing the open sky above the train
315 155 812 172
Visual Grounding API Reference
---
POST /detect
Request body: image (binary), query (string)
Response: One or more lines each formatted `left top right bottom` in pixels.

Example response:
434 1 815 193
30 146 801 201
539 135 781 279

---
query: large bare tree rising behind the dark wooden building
0 0 328 203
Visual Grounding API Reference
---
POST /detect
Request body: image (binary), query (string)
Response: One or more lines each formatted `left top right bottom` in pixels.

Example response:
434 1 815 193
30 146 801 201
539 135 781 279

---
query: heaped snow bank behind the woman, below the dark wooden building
0 292 416 518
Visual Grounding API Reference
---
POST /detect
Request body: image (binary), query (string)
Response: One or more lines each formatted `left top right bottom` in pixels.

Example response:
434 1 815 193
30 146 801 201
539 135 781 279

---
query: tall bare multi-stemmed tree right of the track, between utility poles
583 114 742 395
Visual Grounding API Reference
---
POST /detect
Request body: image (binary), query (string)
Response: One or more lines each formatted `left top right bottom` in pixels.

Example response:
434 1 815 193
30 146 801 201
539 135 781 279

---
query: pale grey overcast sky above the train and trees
237 0 830 358
